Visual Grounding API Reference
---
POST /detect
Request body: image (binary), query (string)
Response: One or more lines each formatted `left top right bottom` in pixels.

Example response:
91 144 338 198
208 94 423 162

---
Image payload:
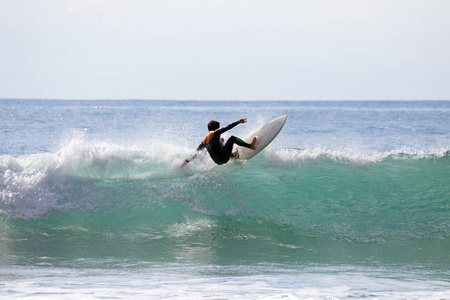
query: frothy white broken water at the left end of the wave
0 138 145 218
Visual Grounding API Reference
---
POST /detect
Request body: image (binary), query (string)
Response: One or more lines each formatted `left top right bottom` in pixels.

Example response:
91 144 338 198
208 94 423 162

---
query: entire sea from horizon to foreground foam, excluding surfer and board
0 100 450 299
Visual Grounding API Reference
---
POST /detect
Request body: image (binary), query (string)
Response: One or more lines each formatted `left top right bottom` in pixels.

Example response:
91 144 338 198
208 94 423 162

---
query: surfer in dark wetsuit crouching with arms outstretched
180 119 258 168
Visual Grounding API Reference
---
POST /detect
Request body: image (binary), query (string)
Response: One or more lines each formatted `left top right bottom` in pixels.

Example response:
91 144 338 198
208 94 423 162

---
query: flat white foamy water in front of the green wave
0 265 450 300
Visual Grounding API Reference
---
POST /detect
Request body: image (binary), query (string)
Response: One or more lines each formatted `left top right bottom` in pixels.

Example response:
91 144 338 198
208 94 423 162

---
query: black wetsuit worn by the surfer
191 121 251 165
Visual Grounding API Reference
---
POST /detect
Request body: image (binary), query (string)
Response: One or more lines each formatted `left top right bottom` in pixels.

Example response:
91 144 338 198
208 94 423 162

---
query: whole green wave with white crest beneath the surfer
0 139 450 274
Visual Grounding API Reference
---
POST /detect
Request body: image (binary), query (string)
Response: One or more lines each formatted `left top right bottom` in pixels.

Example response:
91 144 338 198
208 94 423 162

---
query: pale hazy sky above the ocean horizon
0 0 450 100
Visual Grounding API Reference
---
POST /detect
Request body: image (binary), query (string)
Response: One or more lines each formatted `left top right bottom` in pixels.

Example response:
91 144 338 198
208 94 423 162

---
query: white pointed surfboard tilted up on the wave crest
236 115 287 160
